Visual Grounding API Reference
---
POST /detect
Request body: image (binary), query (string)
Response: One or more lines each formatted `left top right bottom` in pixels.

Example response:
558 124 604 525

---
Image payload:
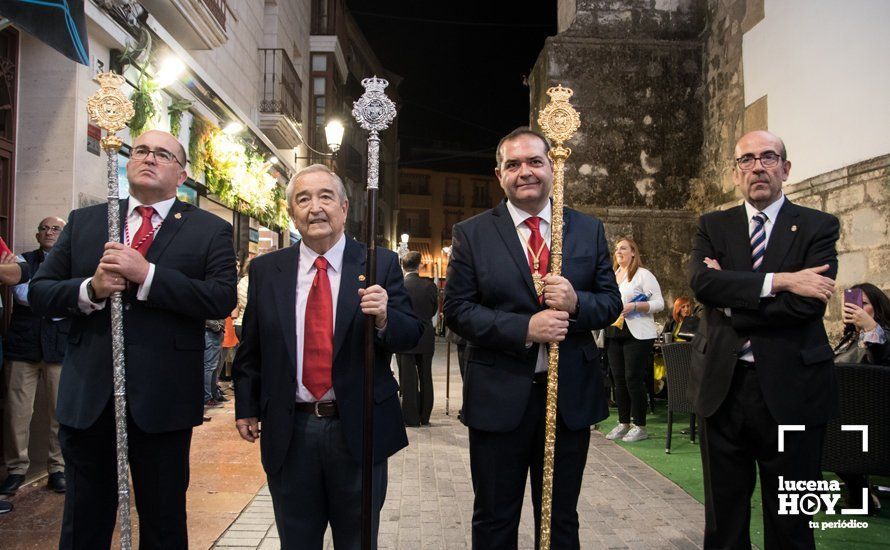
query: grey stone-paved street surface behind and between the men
214 343 704 550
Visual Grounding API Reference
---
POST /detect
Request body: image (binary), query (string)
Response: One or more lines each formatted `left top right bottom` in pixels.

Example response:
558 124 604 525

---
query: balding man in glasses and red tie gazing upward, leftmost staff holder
28 131 236 549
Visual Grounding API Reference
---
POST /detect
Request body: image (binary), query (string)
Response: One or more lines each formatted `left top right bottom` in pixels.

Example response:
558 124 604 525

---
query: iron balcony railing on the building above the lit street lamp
258 49 303 124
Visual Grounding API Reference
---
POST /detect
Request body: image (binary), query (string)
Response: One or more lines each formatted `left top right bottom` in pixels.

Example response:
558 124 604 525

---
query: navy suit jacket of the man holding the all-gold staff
445 200 621 432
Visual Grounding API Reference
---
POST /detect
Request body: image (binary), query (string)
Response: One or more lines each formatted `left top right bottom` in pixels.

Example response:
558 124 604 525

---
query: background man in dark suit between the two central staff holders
396 252 439 427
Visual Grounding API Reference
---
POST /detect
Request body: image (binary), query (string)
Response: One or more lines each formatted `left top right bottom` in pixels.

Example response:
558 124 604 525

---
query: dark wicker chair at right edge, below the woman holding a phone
822 363 890 475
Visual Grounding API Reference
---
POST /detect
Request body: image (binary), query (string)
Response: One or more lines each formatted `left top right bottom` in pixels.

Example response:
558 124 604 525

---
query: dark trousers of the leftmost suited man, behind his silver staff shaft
59 397 197 550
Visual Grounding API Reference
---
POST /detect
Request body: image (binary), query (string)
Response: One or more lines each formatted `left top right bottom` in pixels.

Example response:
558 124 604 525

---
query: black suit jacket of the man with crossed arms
688 202 840 425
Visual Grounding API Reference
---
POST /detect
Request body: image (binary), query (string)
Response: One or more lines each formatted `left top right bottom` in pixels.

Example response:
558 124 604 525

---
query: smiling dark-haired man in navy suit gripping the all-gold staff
445 128 621 550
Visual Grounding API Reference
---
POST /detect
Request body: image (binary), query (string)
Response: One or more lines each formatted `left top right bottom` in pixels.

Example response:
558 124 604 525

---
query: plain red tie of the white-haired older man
303 256 334 399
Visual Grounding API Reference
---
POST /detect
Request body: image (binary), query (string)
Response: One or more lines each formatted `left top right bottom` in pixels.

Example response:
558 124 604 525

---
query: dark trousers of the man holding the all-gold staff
470 384 590 550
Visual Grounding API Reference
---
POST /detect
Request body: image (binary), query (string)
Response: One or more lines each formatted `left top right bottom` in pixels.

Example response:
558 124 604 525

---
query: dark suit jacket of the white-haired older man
232 237 421 474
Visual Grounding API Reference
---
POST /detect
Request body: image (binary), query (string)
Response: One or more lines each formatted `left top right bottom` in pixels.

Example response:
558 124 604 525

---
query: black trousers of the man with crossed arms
701 364 825 550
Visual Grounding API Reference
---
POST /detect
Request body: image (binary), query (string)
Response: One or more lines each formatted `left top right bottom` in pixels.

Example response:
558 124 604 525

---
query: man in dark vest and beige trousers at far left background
0 216 71 495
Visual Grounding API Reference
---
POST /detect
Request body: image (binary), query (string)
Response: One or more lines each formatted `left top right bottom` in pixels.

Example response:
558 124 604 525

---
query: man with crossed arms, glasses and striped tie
689 131 839 549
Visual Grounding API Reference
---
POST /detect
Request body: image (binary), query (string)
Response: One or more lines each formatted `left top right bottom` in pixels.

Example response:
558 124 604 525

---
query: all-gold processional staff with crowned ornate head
538 84 581 550
